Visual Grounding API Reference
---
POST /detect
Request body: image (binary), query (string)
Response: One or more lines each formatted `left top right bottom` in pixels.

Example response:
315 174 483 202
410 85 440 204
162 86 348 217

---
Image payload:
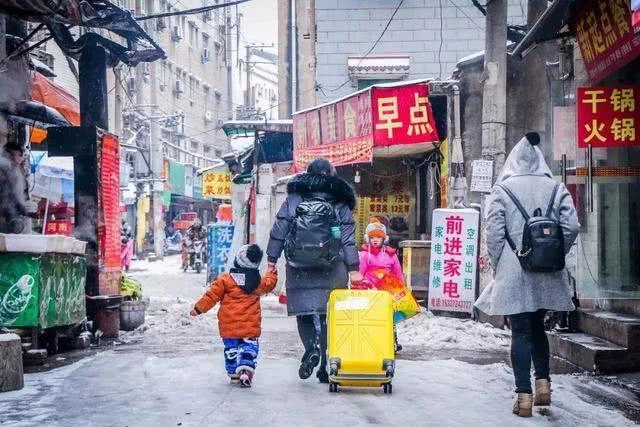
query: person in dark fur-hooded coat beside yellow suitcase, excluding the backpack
267 158 362 383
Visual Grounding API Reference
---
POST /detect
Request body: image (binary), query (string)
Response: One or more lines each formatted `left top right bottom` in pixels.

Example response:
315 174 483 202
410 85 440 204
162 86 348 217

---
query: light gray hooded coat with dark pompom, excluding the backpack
475 134 580 315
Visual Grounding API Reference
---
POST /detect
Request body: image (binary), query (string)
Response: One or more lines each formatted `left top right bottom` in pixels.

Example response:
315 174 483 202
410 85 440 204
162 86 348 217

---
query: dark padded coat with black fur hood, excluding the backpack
267 173 360 316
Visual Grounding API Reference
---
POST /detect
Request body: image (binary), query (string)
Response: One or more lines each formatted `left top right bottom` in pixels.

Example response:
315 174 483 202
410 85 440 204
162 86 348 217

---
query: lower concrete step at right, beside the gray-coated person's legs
547 332 640 374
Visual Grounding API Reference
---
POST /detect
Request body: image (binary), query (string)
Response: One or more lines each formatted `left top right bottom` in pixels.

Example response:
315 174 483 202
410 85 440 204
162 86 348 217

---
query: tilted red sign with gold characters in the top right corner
576 0 640 83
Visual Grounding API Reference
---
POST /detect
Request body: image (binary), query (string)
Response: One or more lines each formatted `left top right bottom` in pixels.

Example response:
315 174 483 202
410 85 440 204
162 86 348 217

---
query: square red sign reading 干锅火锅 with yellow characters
576 86 640 148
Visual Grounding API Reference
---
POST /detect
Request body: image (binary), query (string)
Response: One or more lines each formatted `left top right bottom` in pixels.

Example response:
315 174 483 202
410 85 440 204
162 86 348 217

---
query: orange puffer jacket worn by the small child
195 273 278 338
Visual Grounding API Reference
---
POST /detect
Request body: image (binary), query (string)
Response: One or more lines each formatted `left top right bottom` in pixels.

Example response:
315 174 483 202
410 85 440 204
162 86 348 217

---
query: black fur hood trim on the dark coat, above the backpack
287 173 356 210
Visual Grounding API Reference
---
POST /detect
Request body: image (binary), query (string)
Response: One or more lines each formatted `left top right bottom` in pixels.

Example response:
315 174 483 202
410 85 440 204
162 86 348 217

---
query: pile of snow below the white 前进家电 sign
398 312 511 351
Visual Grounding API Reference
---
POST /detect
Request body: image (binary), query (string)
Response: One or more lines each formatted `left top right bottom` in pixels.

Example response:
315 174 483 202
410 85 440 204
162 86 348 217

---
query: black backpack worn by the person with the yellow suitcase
284 197 342 269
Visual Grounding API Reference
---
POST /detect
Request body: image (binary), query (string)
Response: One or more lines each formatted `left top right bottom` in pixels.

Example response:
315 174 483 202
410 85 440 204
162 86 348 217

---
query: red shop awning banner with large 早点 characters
293 80 439 170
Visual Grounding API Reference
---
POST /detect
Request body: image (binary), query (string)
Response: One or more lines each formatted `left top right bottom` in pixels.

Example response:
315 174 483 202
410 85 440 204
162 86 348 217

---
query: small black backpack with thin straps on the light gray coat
498 183 565 273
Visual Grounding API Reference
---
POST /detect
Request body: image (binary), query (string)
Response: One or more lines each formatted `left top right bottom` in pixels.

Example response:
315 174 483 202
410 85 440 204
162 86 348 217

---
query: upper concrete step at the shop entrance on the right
576 308 640 351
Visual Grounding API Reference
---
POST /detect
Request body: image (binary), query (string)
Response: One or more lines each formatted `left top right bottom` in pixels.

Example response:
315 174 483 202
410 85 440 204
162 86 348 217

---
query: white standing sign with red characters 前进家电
428 209 480 313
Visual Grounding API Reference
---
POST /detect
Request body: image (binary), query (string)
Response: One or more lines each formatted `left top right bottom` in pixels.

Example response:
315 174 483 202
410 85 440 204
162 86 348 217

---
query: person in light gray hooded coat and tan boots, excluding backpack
475 133 580 416
